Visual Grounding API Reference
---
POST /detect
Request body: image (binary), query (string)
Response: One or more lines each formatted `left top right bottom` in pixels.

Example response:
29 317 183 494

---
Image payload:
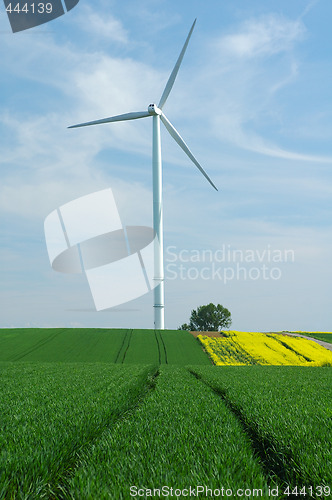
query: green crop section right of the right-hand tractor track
193 366 332 487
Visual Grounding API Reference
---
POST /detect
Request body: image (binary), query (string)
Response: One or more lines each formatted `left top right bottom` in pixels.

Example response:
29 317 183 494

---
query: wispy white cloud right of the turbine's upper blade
200 14 332 163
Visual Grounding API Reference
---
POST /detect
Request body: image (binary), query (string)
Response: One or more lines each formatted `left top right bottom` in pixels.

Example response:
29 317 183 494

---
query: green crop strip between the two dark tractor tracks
67 365 272 500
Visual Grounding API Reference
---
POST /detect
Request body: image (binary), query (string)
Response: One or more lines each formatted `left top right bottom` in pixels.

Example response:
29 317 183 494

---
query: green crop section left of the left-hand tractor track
0 363 156 500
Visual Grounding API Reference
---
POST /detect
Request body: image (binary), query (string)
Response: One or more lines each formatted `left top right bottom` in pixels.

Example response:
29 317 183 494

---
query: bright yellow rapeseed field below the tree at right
198 331 332 366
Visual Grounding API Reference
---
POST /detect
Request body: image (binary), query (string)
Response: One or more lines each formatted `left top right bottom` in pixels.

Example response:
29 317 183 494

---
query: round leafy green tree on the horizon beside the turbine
179 303 232 332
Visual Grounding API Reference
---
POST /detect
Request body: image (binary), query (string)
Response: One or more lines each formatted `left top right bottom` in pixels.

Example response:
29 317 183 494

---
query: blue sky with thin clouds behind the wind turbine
0 0 332 331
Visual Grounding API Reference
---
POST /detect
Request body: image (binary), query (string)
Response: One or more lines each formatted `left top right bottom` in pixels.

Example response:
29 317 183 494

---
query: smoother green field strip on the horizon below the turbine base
0 328 210 365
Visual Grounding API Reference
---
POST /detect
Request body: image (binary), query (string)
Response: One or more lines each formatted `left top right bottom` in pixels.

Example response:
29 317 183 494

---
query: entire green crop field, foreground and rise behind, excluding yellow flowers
0 329 332 500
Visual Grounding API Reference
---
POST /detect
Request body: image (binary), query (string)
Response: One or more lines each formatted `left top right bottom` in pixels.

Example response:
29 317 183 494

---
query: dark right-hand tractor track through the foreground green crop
188 369 315 499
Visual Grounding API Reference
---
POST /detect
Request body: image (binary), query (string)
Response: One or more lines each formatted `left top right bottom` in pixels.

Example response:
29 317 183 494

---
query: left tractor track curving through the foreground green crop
47 368 159 500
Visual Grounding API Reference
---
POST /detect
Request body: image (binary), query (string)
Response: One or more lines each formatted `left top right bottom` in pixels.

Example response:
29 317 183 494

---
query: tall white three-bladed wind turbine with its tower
68 19 218 330
